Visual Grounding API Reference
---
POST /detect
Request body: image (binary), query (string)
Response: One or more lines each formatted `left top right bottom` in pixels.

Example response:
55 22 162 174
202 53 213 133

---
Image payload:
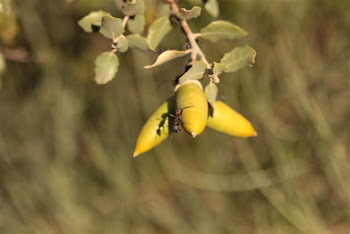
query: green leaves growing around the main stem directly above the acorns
140 1 256 107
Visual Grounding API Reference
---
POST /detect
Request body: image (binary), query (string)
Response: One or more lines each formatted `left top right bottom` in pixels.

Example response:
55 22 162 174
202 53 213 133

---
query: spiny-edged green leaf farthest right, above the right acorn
214 46 256 72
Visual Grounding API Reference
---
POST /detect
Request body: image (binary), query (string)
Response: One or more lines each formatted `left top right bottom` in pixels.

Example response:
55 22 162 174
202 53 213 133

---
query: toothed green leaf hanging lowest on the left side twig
95 52 119 84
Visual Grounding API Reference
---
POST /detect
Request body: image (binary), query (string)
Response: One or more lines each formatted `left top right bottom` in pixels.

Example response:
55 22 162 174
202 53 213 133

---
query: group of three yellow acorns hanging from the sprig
133 80 257 157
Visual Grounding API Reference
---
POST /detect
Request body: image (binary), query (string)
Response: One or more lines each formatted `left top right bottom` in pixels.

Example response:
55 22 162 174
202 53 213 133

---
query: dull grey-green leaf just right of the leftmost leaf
100 16 124 39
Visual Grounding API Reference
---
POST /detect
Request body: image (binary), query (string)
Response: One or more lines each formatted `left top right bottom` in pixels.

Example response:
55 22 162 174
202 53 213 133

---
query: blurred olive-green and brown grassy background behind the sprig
0 0 350 233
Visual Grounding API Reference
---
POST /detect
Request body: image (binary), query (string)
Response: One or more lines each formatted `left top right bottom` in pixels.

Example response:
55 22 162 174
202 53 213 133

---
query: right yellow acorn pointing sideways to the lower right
207 101 257 137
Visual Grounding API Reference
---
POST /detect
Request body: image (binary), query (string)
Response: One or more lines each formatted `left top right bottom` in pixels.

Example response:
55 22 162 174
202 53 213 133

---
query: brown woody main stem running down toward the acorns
167 0 219 83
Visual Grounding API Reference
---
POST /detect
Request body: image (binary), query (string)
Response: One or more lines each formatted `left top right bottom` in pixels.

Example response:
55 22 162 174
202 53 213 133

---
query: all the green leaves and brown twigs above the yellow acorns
78 0 256 107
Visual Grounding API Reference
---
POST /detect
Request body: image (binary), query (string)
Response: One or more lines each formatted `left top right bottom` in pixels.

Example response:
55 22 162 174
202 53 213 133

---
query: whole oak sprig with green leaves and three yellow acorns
78 0 256 157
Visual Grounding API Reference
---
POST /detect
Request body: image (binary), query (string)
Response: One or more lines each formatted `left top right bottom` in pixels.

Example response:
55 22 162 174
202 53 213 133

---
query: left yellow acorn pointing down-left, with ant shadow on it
133 99 175 157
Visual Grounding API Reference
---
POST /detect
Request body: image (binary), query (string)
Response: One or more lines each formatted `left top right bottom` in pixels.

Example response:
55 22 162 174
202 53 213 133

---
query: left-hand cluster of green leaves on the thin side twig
78 0 150 84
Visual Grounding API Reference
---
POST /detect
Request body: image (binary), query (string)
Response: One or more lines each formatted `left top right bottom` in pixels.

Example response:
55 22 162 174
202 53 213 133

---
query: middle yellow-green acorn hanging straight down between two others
175 80 208 137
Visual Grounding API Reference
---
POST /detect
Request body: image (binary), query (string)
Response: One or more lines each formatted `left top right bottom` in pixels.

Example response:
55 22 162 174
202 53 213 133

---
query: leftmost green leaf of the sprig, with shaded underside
78 11 111 33
